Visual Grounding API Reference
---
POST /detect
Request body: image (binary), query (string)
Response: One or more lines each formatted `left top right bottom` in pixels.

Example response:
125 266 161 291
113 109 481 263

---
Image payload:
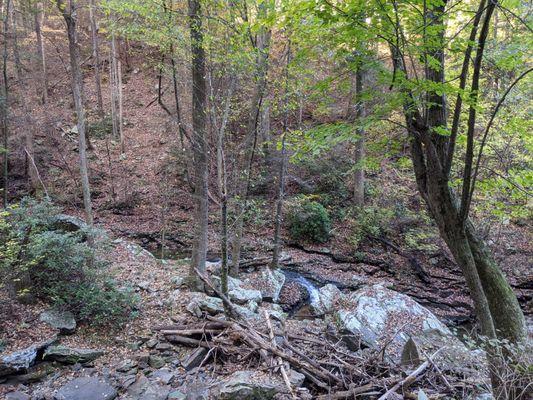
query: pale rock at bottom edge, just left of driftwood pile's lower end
217 371 280 400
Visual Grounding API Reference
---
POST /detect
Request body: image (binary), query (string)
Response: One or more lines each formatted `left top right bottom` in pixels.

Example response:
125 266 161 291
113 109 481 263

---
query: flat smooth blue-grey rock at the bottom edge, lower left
54 377 117 400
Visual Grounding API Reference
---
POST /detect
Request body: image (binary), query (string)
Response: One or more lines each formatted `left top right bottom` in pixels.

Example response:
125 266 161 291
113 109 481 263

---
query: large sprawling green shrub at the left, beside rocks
0 199 136 323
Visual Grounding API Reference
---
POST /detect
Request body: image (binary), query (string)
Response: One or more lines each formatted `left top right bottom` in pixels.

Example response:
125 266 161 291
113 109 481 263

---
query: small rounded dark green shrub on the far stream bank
287 197 331 243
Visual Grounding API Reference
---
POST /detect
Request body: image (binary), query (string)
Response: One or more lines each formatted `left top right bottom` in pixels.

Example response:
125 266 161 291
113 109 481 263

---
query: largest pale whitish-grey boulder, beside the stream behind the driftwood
334 285 452 359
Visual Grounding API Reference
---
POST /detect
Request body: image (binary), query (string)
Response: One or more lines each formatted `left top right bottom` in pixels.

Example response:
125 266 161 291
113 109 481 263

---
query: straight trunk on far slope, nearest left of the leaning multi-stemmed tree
353 65 365 207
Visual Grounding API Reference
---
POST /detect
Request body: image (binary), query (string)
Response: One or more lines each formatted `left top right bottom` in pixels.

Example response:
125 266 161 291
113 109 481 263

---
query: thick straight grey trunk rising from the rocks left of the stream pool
189 0 209 289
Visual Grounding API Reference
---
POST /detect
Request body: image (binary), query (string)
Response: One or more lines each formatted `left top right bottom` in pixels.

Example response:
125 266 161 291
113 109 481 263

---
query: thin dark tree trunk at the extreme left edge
1 0 11 208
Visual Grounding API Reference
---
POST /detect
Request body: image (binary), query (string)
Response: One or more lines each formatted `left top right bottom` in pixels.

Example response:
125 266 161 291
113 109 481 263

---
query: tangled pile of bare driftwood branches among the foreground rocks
149 276 462 400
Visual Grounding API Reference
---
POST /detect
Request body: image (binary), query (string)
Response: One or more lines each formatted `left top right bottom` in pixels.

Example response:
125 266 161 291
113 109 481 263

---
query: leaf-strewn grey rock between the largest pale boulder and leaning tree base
401 329 486 377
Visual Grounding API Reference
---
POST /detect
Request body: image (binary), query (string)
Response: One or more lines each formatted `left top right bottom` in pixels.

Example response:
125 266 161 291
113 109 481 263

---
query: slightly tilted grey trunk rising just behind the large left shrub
57 0 93 225
